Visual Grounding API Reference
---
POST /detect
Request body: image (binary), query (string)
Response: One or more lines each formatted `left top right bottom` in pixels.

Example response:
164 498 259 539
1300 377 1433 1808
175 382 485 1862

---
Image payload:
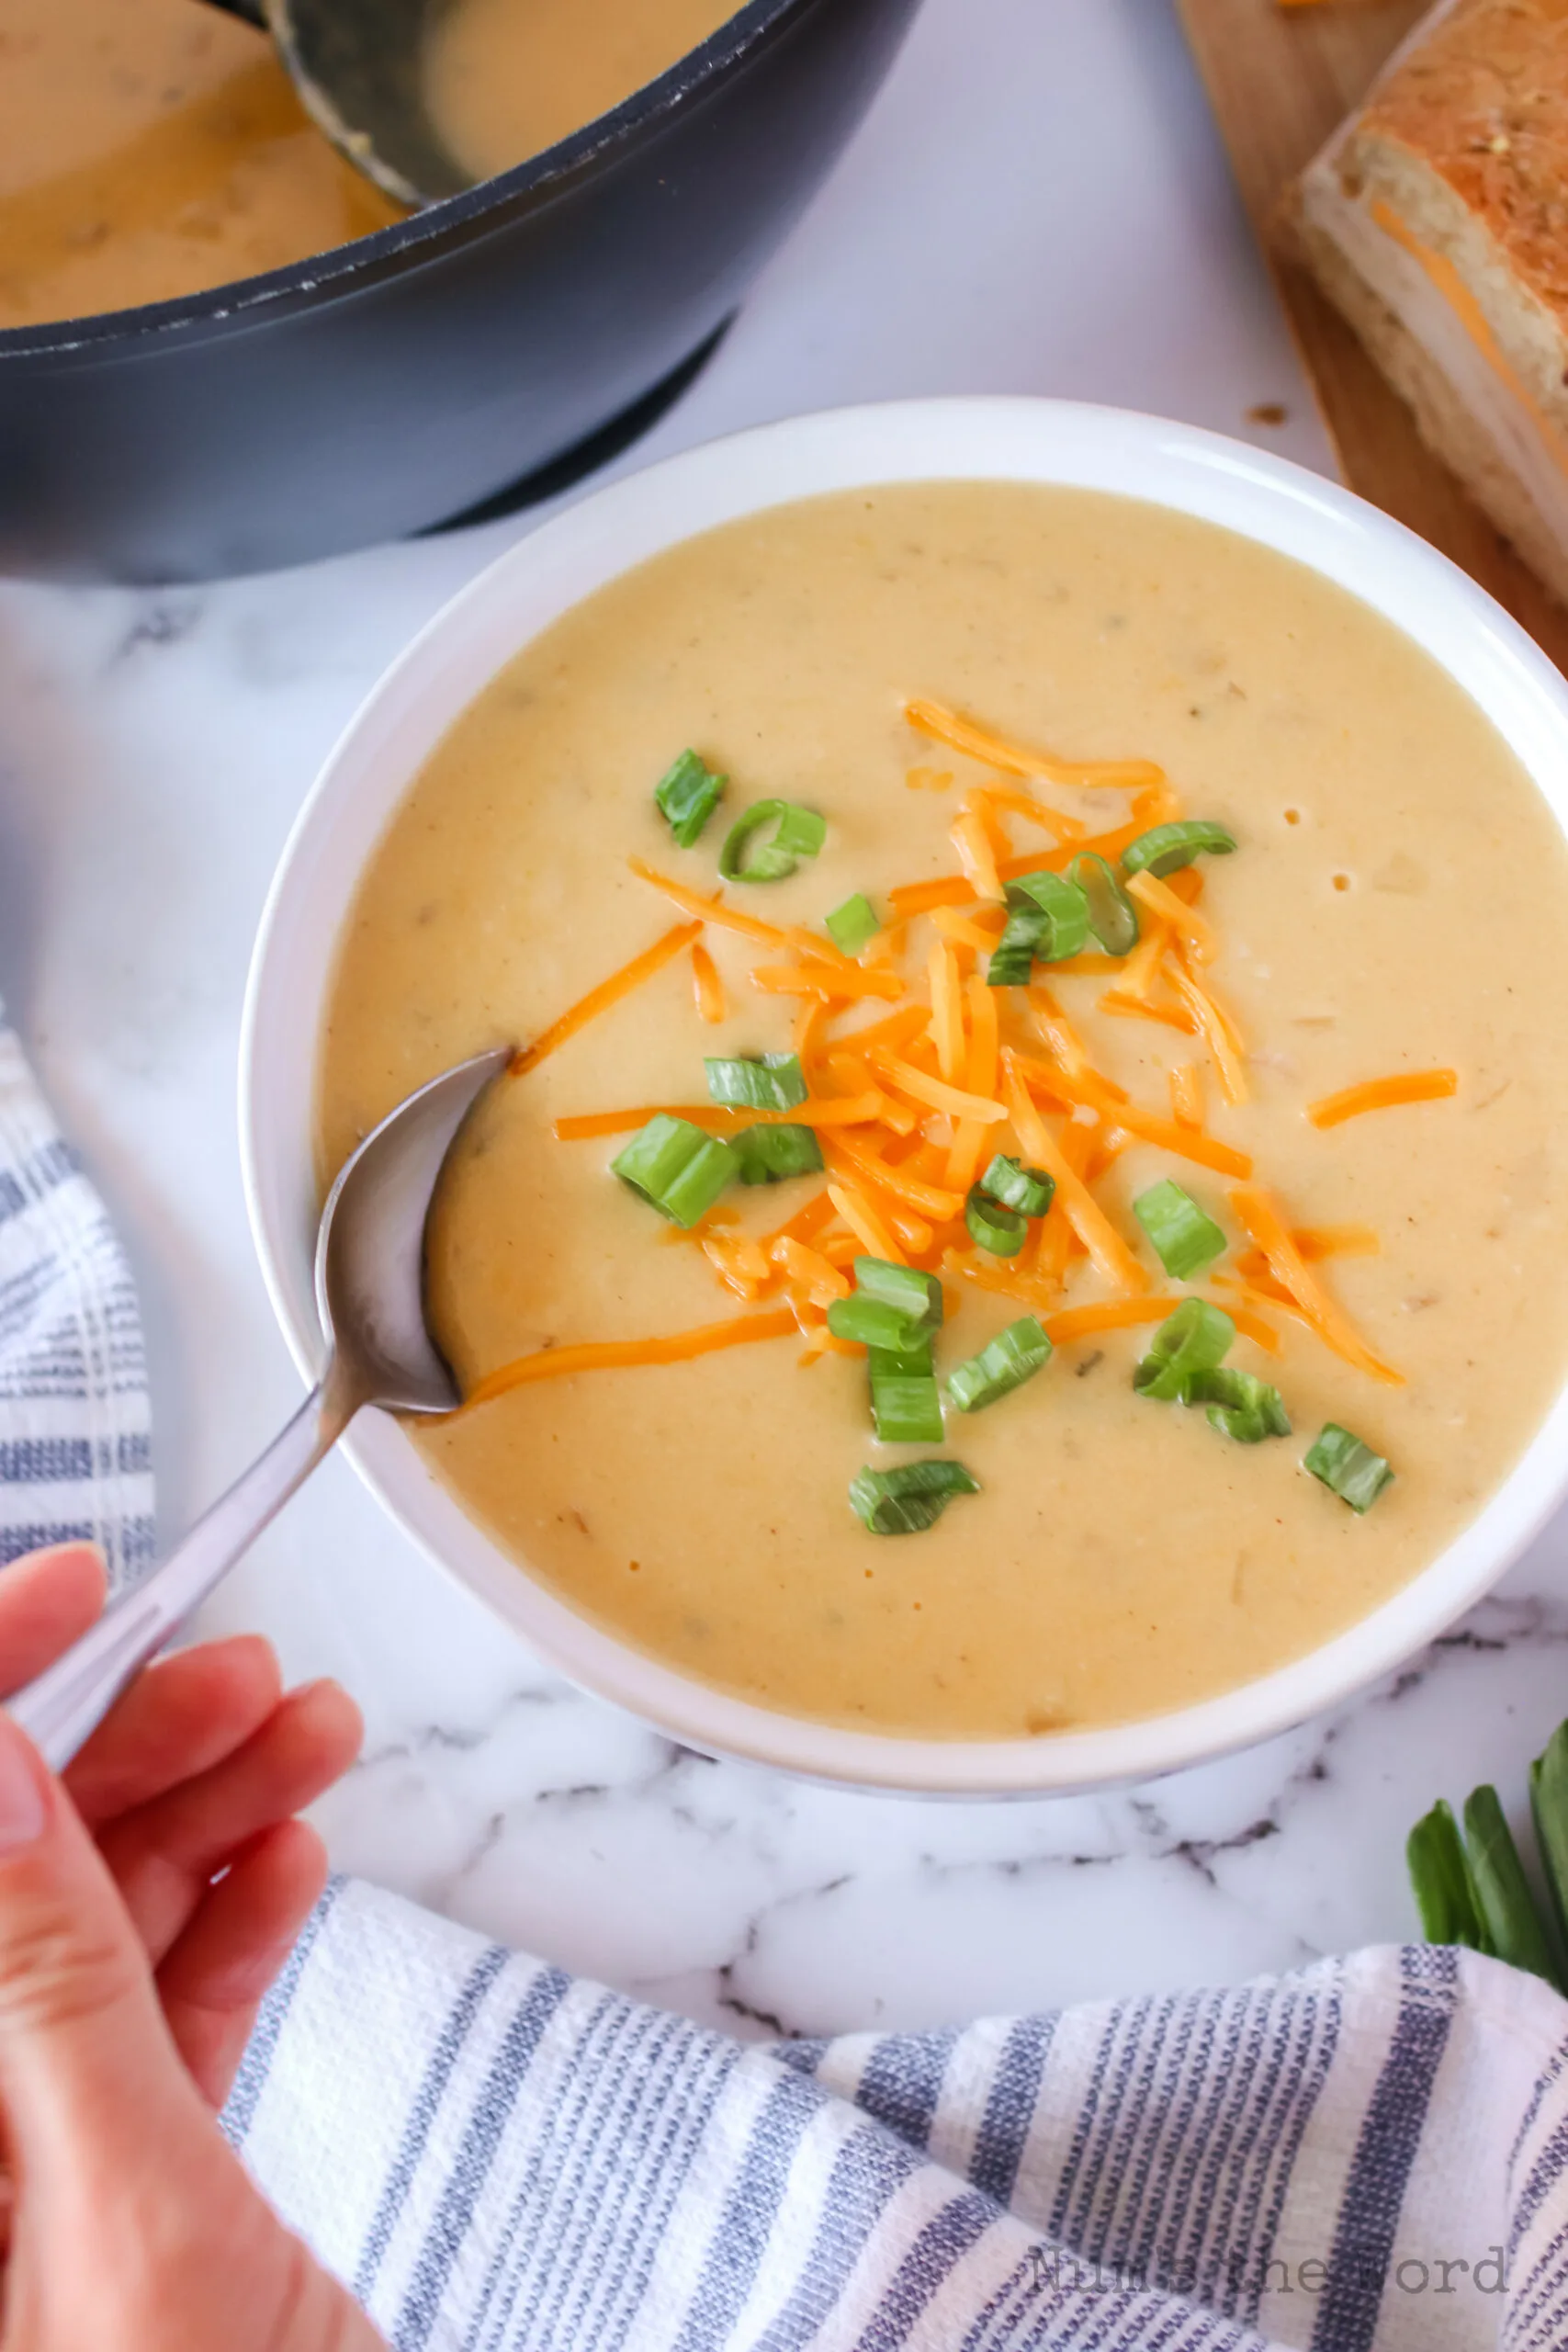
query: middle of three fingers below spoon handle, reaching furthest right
98 1681 362 1966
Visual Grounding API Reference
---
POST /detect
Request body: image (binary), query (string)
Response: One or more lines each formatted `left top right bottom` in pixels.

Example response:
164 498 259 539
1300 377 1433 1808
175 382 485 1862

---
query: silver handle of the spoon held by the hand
5 1371 357 1771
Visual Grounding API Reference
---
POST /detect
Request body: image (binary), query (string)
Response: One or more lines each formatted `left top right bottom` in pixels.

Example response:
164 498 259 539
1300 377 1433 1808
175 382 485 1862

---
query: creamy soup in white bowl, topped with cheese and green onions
310 484 1568 1738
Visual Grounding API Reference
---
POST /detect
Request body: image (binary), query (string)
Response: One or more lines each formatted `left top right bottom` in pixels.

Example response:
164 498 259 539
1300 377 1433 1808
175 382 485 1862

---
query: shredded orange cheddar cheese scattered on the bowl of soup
468 701 1419 1407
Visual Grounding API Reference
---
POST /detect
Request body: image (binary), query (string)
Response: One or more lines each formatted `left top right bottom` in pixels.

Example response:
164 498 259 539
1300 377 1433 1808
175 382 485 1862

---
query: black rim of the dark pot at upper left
0 0 808 362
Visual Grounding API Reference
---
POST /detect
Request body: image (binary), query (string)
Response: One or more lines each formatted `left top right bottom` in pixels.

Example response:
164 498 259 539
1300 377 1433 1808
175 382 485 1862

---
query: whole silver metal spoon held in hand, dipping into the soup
5 1046 510 1771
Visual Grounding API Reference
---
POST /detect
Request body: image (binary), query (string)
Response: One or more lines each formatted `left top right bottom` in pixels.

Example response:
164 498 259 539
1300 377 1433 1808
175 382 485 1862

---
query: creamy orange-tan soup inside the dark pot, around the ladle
0 0 733 329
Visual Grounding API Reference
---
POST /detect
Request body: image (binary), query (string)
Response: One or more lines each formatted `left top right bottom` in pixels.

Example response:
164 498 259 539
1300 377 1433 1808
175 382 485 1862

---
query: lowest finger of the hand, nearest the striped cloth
157 1820 327 2108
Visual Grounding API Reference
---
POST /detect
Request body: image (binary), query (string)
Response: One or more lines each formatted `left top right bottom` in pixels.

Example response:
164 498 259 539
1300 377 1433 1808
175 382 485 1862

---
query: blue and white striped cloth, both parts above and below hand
0 1030 1568 2352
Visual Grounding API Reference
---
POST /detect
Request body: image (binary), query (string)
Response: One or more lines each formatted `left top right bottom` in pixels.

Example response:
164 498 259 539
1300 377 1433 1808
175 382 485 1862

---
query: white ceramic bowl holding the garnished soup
240 400 1568 1794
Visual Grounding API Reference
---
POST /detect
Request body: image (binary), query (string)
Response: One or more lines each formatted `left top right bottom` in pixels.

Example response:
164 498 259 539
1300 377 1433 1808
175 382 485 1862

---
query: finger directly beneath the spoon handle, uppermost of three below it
63 1634 282 1823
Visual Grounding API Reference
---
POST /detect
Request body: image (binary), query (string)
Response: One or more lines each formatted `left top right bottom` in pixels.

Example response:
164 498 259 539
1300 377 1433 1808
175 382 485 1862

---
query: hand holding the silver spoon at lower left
0 1545 381 2352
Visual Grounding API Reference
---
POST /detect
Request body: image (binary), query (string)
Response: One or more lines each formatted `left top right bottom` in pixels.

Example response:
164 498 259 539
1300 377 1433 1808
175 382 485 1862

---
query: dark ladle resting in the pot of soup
196 0 475 207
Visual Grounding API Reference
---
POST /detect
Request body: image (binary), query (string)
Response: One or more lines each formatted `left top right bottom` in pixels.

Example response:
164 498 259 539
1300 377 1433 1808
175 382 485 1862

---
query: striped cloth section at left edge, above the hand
0 1013 152 1590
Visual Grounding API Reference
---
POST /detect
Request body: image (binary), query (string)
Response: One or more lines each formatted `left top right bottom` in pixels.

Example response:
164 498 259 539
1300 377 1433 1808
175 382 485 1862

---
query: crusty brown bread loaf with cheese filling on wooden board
1293 0 1568 605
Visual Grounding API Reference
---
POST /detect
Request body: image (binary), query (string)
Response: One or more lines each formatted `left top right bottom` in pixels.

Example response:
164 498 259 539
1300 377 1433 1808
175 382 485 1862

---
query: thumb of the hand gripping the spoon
0 1713 195 2188
